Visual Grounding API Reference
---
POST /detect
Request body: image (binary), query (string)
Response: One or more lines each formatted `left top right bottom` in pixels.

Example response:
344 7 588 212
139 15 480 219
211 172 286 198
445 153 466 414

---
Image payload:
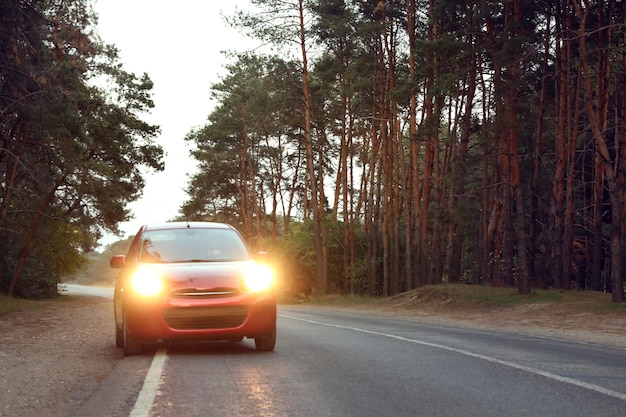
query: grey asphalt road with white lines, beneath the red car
68 286 626 417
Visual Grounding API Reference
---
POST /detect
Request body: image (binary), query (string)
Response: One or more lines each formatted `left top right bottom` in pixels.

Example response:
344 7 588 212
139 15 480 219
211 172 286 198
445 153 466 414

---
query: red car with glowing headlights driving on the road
110 222 276 355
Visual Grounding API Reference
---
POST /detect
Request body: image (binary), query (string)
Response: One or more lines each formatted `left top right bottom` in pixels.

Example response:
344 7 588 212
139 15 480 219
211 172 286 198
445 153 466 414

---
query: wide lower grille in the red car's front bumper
163 306 248 330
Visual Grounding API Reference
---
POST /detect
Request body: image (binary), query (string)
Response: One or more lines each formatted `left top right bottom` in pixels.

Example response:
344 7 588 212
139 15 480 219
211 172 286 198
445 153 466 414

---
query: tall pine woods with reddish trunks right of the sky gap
182 0 626 302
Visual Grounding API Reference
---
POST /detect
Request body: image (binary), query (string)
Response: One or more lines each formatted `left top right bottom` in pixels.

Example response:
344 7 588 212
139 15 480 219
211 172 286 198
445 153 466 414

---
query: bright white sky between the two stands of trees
94 0 256 245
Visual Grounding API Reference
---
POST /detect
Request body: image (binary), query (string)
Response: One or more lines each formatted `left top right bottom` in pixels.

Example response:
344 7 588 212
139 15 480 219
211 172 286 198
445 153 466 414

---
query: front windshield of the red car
139 228 250 263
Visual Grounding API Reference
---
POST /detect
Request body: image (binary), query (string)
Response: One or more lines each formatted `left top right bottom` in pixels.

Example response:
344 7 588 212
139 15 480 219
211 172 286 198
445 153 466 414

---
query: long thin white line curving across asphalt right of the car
280 314 626 401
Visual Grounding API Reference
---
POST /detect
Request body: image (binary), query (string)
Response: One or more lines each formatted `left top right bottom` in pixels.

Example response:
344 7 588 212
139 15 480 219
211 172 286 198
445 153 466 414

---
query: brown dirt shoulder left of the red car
0 297 123 417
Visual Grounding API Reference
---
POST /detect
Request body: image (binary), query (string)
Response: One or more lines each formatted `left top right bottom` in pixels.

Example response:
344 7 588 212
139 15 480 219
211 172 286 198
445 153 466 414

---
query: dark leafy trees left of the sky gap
0 0 163 298
